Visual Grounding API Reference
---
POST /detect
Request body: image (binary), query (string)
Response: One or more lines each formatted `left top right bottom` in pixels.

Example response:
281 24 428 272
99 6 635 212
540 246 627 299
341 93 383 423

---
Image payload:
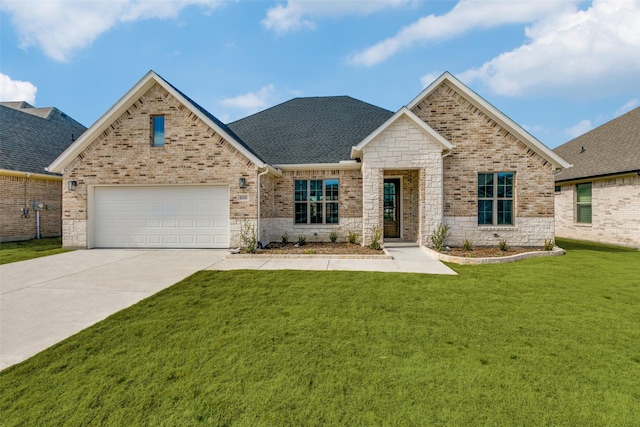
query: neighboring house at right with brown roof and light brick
554 108 640 248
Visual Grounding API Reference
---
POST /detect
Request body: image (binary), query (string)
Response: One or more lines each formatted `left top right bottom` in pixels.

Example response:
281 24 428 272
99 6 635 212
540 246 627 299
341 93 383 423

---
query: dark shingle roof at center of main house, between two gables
228 96 393 165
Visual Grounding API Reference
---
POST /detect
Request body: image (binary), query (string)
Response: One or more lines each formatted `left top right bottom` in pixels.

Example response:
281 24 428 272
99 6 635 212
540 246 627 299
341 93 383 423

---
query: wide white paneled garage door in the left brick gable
93 186 229 248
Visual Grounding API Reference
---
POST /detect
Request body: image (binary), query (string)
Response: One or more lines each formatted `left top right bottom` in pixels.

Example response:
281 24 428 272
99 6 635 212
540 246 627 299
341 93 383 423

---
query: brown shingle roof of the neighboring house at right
554 107 640 182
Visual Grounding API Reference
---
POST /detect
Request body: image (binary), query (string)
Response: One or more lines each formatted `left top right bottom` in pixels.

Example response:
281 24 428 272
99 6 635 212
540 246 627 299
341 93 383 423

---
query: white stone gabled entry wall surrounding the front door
362 117 442 245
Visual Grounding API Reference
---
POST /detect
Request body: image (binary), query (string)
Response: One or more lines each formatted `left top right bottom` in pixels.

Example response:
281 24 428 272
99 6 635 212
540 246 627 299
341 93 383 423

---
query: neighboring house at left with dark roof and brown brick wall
0 102 86 242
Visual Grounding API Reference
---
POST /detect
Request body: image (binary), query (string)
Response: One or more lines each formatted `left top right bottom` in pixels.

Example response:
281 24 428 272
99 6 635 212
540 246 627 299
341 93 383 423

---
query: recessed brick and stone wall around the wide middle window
260 170 362 243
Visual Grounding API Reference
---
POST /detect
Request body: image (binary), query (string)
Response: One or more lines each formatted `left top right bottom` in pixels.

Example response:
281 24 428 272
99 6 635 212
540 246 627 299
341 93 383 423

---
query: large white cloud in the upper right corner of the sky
459 0 640 97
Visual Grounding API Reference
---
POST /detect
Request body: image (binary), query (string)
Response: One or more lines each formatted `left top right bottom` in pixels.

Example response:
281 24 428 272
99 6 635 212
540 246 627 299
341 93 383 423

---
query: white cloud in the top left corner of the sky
1 0 221 62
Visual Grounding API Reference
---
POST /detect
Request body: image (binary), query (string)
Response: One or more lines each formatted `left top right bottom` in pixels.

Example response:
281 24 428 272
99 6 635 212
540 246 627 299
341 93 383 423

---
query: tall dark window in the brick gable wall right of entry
478 172 515 225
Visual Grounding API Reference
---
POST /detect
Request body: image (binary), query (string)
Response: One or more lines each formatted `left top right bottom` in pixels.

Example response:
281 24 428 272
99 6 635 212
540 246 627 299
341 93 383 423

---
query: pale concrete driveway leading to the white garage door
0 249 228 369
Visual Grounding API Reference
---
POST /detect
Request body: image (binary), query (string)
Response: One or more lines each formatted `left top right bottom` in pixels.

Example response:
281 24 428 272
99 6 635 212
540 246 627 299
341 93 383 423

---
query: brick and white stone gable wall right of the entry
413 83 554 246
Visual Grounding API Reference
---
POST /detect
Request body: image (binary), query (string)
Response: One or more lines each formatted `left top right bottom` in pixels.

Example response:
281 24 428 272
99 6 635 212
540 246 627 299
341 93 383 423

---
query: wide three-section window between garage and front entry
294 179 340 224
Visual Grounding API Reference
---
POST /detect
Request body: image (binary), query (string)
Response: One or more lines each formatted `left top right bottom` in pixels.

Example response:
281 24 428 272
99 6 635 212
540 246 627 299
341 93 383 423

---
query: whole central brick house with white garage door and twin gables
49 71 568 248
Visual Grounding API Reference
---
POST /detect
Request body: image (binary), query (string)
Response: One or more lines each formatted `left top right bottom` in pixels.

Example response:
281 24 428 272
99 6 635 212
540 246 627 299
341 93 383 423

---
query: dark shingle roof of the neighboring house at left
0 101 86 175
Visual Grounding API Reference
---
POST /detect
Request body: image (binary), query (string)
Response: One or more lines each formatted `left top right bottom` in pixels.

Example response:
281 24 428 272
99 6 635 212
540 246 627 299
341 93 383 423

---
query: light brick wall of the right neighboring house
555 174 640 248
